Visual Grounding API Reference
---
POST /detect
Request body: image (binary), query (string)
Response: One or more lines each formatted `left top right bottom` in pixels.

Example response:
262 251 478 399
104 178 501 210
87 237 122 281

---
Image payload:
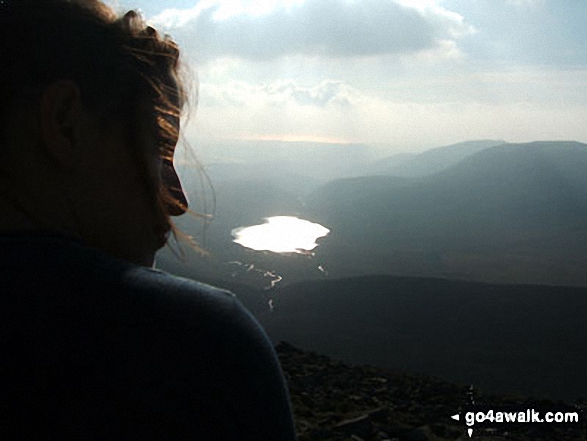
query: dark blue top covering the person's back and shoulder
0 233 295 441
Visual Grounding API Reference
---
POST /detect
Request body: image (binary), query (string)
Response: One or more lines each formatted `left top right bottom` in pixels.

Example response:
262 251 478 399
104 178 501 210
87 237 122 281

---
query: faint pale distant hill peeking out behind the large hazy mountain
355 140 505 177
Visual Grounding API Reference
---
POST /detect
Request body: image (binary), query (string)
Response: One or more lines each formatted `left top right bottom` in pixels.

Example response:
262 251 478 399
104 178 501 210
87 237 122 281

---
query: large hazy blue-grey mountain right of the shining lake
305 142 587 285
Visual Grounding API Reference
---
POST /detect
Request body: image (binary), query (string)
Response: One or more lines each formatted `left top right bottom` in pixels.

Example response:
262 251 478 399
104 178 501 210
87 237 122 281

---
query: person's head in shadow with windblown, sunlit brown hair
0 0 187 265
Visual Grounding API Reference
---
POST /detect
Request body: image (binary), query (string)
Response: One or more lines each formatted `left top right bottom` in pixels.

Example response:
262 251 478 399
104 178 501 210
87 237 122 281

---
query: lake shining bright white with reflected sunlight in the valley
232 216 330 253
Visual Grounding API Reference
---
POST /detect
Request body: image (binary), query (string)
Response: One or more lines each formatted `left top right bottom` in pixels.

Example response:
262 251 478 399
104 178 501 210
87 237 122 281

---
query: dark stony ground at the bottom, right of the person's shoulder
276 342 587 441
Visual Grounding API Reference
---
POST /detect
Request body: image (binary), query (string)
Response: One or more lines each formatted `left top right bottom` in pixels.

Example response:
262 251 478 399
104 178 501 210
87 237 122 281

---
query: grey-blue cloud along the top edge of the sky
153 0 472 62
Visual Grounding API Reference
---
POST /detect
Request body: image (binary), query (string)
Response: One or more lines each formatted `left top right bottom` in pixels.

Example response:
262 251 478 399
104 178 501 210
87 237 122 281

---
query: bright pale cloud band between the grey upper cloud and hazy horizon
185 64 587 150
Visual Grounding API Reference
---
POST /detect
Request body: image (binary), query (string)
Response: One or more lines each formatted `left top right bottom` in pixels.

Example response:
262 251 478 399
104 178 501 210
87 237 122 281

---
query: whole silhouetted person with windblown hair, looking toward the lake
0 0 295 441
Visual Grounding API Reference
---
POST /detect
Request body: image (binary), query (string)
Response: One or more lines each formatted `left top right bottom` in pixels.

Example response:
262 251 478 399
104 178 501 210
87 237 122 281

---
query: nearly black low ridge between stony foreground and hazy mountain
253 276 587 400
